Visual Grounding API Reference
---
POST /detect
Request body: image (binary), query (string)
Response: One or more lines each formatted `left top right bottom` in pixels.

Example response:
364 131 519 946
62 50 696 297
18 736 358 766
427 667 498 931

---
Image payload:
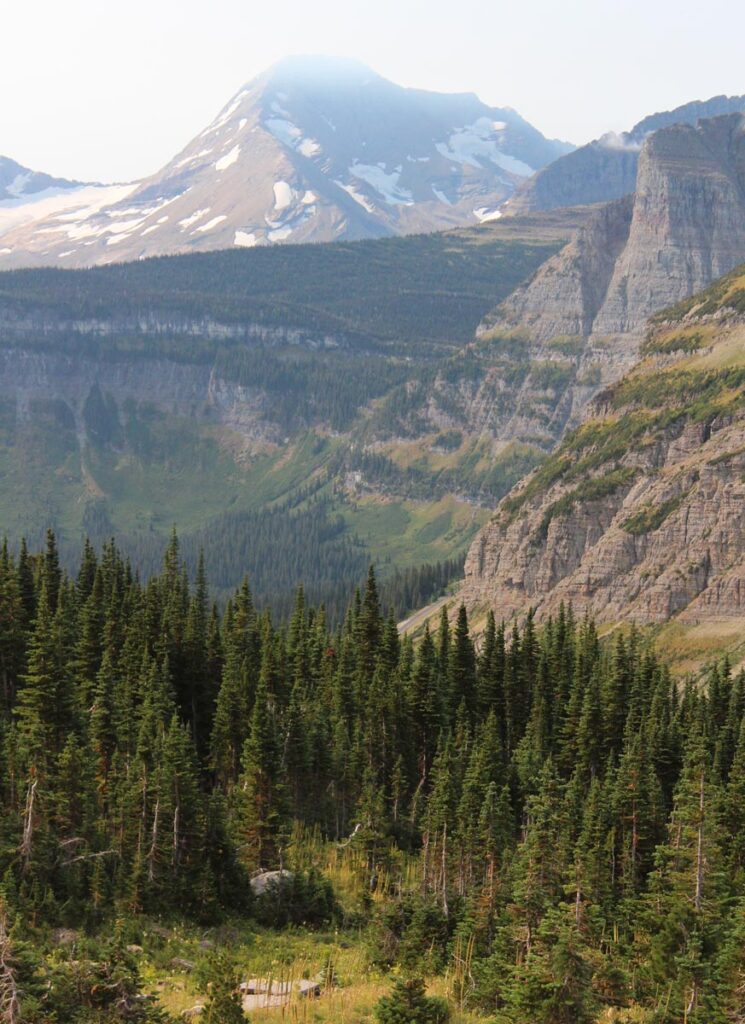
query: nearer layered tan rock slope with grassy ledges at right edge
464 267 745 643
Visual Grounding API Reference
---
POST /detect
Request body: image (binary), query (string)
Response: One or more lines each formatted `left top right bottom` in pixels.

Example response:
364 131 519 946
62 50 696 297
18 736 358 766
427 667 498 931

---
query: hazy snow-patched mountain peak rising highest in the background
3 56 571 266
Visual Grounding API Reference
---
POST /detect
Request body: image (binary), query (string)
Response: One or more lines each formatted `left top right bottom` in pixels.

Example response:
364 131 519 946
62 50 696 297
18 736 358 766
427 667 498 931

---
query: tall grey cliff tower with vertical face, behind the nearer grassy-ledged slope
462 114 745 447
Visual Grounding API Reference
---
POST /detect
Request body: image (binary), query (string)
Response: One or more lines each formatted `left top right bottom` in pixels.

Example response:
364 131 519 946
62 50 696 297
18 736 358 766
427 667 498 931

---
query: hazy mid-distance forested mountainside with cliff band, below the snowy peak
0 212 582 614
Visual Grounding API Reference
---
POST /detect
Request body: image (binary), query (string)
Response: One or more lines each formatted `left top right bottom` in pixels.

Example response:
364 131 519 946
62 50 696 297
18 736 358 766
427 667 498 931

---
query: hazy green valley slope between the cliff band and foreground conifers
0 403 485 613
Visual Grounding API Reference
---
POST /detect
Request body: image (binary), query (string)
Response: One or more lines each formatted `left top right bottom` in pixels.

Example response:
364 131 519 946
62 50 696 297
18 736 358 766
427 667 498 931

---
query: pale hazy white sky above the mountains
0 0 745 181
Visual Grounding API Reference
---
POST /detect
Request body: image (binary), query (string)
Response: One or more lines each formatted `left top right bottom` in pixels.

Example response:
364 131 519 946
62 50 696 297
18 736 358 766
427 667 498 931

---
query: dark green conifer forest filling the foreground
0 535 745 1024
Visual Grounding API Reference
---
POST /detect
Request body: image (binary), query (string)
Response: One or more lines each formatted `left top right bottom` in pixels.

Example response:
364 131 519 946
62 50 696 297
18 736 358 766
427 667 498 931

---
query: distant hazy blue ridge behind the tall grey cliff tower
502 96 745 215
